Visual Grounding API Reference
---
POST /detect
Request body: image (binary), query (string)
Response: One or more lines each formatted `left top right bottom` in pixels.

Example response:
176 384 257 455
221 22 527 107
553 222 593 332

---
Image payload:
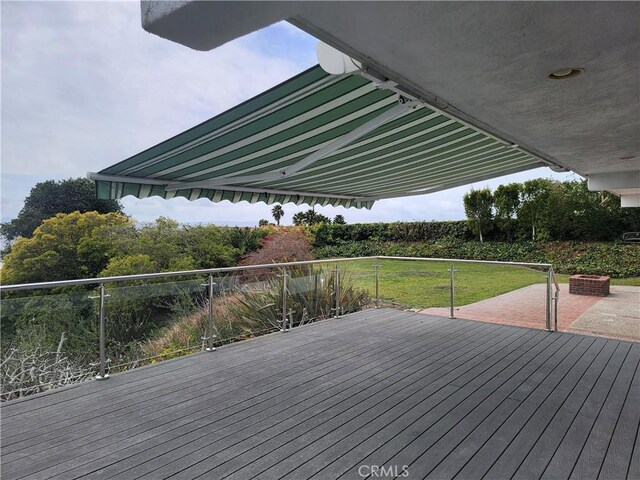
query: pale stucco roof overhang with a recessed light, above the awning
142 1 640 206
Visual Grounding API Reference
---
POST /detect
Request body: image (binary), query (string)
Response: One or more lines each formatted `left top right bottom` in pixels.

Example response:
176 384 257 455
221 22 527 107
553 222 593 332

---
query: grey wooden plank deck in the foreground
2 309 640 480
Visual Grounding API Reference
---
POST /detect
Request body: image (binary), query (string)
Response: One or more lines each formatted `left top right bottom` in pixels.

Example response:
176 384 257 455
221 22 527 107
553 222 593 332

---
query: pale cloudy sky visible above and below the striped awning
0 1 579 225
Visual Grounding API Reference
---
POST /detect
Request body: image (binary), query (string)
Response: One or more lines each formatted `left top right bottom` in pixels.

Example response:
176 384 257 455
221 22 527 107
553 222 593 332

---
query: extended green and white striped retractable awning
89 66 544 208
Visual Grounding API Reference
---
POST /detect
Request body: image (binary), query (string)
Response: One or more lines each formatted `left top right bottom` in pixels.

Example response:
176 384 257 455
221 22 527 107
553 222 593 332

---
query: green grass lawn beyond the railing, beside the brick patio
332 260 640 308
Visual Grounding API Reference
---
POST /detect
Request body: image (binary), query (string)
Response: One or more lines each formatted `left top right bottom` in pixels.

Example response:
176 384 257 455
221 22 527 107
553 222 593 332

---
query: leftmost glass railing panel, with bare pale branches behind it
0 287 98 401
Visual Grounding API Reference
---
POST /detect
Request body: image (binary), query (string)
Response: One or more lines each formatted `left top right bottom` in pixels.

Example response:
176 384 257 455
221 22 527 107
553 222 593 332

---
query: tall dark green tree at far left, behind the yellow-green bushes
0 178 122 240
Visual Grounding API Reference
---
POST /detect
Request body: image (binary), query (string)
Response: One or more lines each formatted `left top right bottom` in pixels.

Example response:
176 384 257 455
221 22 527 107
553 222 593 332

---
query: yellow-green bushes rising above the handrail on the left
2 212 266 284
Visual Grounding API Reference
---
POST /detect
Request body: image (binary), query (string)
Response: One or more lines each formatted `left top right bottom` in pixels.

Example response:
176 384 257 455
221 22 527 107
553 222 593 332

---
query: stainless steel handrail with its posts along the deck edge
0 256 559 394
